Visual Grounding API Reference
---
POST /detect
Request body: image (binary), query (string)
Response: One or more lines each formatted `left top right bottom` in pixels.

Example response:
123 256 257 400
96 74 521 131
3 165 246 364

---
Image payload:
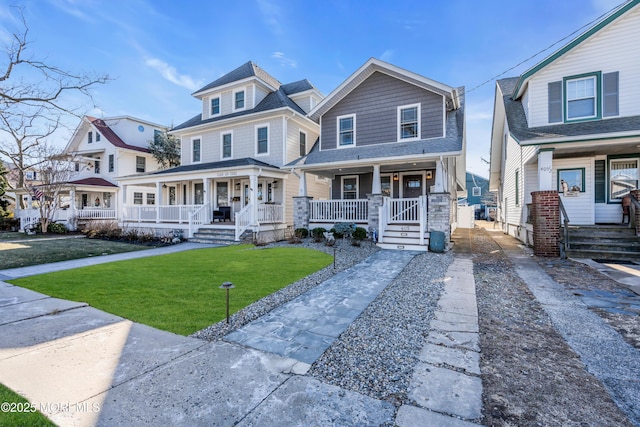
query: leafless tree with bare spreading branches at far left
0 9 110 203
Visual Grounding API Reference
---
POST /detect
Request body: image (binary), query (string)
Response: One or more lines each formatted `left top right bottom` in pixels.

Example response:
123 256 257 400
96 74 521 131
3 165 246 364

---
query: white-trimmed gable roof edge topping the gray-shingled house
309 58 460 121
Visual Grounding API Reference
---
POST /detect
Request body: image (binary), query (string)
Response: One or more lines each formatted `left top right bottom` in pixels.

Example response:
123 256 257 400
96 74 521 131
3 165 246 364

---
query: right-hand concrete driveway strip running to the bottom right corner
484 232 640 426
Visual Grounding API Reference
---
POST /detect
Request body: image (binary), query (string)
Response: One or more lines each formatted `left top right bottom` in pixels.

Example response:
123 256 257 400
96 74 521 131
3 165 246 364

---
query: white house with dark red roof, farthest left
17 116 166 229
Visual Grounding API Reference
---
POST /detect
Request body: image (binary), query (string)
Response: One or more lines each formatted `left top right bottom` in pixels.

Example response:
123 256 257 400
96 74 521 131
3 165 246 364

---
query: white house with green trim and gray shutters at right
490 0 640 252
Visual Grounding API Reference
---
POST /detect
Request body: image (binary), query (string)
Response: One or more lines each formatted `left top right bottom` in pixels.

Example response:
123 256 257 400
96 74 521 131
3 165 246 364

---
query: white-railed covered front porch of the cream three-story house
120 162 287 241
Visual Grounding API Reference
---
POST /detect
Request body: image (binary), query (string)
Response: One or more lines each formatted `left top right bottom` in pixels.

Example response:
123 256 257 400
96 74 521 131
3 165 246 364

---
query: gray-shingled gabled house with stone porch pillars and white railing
287 58 465 250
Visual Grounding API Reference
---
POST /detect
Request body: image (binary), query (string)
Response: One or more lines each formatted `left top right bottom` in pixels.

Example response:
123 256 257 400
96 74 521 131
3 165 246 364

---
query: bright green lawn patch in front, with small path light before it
10 245 332 335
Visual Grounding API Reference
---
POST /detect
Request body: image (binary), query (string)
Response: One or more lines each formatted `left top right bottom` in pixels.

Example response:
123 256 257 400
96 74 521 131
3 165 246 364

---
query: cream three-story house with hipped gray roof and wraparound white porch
119 62 329 240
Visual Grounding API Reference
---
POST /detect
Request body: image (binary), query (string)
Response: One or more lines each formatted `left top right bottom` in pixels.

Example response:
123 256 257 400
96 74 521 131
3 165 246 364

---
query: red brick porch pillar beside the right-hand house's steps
531 190 560 257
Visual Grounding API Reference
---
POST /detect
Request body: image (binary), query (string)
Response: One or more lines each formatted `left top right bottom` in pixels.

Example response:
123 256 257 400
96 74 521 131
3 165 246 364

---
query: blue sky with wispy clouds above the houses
0 0 622 177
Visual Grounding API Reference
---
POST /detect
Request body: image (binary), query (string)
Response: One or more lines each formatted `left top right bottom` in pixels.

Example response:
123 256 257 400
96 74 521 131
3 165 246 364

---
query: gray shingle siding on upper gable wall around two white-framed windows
321 72 443 150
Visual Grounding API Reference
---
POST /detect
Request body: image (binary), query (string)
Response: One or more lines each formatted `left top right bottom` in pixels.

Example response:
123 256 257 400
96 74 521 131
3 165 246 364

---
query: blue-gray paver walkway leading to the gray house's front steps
225 250 419 364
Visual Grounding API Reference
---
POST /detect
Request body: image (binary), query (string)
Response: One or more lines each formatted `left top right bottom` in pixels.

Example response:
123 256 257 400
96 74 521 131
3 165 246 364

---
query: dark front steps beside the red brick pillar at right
561 225 640 261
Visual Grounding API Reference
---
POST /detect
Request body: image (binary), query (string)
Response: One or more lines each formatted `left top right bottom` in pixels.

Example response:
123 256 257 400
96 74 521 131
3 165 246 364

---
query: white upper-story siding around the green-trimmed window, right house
528 5 640 127
